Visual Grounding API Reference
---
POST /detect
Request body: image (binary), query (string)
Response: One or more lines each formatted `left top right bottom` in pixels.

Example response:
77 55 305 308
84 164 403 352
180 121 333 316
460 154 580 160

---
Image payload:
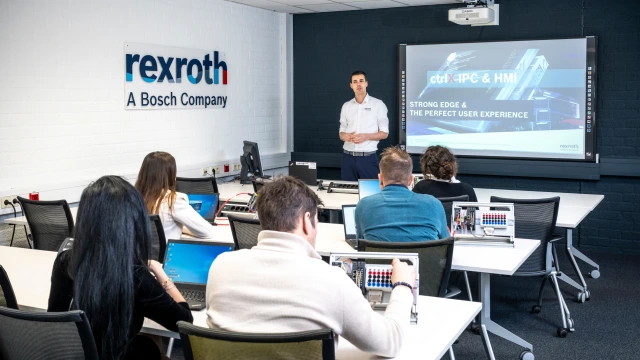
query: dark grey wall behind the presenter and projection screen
293 0 640 253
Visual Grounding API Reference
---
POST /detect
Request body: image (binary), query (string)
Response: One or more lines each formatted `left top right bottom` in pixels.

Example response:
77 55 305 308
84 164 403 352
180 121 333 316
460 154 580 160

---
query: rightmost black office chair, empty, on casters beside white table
491 196 574 337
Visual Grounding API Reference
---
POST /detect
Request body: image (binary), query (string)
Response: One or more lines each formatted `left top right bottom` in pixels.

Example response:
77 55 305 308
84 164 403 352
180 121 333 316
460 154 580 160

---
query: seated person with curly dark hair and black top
413 145 478 202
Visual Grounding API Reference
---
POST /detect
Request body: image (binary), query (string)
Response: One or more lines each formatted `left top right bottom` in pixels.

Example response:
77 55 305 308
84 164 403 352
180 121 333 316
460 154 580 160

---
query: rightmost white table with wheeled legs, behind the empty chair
474 188 604 302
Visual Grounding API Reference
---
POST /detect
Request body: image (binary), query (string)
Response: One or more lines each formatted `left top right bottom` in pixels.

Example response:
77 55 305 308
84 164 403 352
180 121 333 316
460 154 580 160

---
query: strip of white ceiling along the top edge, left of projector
229 0 462 14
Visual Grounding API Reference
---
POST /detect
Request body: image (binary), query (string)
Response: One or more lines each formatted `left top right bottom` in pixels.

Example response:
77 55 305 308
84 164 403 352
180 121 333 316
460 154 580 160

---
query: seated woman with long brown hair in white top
136 151 214 240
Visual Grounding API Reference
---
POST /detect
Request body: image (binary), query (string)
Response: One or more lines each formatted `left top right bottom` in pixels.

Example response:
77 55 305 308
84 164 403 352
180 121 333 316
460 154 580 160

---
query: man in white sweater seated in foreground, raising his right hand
207 177 416 357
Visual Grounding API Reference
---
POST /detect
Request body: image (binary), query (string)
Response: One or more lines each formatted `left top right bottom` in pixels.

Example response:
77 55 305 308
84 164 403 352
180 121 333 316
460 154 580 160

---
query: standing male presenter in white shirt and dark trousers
340 71 389 181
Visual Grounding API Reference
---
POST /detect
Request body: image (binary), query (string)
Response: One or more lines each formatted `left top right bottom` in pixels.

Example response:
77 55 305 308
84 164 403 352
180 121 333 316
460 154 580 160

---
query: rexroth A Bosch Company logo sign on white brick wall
124 43 229 110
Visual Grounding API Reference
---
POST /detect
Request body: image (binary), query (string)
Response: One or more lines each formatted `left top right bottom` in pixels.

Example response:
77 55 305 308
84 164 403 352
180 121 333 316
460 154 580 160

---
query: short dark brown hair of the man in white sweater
256 176 323 232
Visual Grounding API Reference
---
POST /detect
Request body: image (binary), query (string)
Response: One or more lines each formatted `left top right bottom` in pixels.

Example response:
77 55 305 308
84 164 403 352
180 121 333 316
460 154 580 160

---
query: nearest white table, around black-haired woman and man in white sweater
0 246 481 360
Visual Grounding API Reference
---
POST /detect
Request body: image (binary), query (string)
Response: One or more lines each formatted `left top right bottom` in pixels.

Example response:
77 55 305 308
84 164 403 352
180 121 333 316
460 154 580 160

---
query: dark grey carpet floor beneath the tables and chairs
0 225 640 360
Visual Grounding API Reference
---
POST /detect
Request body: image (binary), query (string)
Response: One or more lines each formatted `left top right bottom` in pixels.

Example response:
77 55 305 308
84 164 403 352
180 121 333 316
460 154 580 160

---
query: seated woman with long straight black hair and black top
48 176 193 360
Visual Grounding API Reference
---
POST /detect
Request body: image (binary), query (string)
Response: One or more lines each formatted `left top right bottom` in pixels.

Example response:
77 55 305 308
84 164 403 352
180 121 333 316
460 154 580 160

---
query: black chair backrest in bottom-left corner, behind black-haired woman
0 307 98 360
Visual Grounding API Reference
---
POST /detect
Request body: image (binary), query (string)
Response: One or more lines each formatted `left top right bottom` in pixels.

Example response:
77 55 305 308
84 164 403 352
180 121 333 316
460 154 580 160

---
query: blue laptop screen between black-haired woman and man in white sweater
163 240 233 285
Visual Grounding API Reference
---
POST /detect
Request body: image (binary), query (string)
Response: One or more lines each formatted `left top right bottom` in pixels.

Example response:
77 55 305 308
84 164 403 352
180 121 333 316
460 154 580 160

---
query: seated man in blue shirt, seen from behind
355 146 449 241
